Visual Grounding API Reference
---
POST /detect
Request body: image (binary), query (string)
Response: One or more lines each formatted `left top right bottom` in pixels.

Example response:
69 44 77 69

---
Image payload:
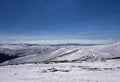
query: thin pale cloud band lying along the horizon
0 39 114 44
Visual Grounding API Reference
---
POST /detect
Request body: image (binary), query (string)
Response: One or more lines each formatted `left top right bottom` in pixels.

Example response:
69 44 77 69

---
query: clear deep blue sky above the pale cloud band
0 0 120 40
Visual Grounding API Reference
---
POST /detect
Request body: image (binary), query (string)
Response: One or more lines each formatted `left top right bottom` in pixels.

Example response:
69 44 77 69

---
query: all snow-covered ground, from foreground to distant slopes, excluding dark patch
0 43 120 82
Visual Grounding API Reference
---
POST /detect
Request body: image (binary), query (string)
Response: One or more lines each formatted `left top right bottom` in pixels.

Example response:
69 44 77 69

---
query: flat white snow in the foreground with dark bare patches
0 60 120 82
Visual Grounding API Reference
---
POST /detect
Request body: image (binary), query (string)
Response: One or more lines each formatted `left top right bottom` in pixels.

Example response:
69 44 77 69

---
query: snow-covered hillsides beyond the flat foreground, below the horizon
0 43 120 64
